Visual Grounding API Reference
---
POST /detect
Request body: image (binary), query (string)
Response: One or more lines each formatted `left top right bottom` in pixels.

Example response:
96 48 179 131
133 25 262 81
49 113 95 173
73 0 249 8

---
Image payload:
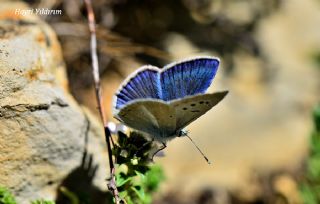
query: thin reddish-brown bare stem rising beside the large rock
84 0 120 203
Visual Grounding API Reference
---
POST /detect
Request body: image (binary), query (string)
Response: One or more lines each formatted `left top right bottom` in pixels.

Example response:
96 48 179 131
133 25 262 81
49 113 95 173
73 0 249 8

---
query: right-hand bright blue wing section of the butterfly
160 57 219 101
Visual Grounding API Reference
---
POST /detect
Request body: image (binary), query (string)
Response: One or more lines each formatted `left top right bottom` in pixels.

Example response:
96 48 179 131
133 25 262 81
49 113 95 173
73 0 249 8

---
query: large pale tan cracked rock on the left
0 1 107 203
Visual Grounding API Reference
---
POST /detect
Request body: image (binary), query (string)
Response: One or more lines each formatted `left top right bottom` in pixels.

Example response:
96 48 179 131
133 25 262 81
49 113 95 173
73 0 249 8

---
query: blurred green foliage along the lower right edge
300 104 320 204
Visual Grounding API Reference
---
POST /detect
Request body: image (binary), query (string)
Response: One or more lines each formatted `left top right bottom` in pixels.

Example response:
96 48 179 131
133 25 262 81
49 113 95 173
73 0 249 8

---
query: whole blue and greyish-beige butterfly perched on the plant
113 57 228 145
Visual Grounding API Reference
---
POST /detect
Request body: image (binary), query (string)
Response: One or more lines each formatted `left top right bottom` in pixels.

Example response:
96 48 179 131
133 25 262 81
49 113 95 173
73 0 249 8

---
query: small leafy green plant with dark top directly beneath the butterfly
113 132 165 204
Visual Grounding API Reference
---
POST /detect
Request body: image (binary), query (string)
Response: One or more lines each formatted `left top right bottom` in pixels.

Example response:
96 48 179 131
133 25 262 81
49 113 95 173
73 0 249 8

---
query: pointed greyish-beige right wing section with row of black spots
170 91 228 130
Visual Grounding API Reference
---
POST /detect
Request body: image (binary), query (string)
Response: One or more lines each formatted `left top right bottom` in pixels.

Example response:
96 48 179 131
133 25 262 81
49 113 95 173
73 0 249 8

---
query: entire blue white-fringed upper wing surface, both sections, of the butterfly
114 57 219 109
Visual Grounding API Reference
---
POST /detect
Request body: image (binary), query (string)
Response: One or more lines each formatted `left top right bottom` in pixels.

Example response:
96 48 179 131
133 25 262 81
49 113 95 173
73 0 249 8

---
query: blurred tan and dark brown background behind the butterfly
26 0 320 203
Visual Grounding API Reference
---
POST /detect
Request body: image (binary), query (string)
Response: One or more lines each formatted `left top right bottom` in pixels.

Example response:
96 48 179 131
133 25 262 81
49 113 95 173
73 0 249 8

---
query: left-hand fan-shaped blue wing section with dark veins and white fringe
115 66 161 109
